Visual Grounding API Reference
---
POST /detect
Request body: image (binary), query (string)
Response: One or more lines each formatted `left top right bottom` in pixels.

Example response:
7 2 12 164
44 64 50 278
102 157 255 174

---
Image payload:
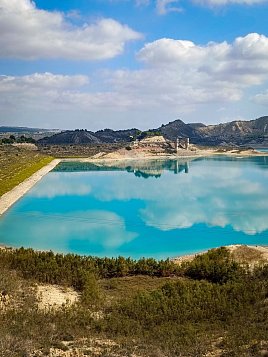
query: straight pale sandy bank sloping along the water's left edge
0 159 61 215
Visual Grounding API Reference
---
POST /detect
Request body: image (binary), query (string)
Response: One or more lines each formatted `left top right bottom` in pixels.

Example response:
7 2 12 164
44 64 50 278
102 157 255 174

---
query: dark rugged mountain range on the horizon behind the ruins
39 116 268 146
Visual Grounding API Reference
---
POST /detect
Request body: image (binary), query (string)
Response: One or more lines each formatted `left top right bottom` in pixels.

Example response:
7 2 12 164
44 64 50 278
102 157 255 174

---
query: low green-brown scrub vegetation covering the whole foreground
0 248 268 357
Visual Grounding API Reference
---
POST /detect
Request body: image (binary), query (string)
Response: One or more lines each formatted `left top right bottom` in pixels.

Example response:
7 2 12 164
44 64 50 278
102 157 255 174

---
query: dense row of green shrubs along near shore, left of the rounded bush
0 248 181 290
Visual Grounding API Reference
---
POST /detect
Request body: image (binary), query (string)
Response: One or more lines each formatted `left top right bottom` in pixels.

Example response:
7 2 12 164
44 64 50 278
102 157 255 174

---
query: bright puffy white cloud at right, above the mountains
138 33 268 85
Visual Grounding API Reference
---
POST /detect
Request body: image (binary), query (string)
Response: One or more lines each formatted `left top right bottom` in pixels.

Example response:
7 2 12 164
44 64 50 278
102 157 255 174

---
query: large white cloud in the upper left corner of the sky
0 0 141 60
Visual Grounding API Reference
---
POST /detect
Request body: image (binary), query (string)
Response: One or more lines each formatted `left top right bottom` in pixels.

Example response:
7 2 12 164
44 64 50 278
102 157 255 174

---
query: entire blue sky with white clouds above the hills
0 0 268 131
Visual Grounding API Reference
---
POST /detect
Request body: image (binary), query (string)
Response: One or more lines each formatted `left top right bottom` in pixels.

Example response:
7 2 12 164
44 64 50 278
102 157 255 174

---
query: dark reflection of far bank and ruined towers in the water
53 159 193 178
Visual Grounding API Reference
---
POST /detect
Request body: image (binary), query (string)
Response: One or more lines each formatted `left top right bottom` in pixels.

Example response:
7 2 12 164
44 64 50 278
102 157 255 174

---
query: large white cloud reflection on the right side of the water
89 160 268 234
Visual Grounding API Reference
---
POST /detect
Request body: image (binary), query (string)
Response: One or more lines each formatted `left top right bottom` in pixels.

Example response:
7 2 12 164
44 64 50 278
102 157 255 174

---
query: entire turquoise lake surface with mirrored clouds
0 156 268 258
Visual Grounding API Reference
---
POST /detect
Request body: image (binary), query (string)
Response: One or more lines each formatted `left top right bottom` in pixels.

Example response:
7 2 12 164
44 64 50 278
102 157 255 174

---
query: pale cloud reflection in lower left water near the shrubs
1 210 137 251
